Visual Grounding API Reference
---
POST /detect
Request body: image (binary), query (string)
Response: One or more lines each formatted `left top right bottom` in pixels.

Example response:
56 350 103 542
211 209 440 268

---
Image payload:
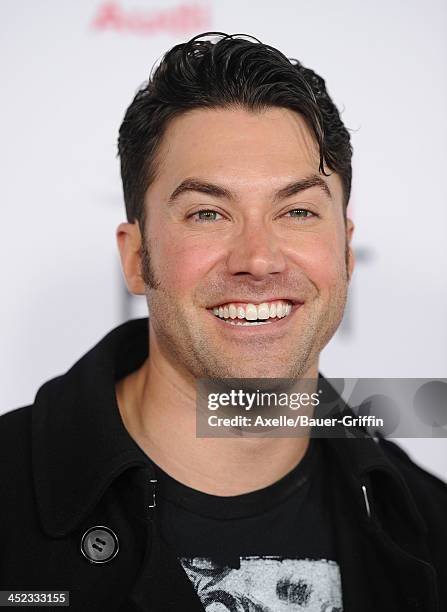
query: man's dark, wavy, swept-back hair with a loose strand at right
118 32 352 229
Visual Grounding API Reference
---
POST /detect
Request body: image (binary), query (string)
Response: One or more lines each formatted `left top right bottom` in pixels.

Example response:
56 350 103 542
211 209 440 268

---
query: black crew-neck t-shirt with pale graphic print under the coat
153 439 342 612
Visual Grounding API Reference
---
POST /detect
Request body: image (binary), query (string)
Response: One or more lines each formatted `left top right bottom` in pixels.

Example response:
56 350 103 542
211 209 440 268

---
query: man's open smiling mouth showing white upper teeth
212 300 294 327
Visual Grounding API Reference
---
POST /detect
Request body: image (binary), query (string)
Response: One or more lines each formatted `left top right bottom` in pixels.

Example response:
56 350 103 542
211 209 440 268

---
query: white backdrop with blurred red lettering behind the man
0 0 447 480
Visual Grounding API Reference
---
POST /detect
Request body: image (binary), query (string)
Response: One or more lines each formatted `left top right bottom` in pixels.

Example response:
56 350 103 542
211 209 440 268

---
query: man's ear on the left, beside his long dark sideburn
116 222 145 295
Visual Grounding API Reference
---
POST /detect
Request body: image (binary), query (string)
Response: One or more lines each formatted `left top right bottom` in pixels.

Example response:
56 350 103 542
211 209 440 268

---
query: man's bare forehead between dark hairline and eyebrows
150 108 341 197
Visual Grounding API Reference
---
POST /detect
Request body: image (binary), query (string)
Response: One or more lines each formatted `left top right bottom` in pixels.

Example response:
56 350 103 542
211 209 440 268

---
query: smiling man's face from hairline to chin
142 108 352 378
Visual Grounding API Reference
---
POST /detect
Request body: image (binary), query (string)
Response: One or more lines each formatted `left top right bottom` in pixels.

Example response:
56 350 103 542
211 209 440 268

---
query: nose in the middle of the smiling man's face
227 222 286 280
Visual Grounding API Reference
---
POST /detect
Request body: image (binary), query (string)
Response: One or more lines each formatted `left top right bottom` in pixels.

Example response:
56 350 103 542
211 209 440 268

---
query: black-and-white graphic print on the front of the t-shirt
180 556 342 612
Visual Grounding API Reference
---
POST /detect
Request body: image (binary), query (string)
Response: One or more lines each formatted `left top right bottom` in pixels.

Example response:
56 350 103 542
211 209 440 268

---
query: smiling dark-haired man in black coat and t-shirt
0 35 447 612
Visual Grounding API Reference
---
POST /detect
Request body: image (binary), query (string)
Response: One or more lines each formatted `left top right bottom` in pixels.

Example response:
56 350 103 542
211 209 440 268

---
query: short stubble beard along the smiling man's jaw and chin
141 238 348 379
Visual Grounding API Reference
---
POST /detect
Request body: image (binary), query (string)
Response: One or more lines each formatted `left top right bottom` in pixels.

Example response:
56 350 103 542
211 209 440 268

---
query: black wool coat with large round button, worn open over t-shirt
0 319 447 612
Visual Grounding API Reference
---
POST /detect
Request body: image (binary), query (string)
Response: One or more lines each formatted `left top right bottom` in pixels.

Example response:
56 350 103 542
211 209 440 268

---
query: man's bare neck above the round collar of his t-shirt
116 334 318 496
